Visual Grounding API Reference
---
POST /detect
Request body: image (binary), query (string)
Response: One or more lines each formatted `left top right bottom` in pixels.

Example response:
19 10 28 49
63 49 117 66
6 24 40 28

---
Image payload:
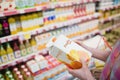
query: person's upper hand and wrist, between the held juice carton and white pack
76 41 111 61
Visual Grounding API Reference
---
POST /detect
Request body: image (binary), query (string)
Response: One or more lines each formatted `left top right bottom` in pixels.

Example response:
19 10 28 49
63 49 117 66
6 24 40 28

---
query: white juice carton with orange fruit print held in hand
46 35 92 69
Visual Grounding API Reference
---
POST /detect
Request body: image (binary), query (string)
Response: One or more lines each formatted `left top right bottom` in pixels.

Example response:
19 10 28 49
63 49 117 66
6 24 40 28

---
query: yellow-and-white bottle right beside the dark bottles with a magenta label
8 17 17 35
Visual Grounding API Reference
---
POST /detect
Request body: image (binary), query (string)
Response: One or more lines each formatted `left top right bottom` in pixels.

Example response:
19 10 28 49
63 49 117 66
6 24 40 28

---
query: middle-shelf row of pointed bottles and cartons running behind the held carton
0 19 98 64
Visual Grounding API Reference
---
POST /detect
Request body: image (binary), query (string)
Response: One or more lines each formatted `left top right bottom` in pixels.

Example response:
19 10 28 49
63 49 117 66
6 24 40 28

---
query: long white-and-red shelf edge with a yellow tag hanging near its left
0 13 100 43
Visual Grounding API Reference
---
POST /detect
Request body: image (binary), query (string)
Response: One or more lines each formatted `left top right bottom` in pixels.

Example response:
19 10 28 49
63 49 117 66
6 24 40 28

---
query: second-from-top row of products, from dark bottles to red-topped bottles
0 3 95 37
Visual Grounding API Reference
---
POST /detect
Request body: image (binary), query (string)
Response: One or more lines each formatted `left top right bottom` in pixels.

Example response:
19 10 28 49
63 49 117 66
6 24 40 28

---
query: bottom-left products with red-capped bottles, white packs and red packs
0 55 72 80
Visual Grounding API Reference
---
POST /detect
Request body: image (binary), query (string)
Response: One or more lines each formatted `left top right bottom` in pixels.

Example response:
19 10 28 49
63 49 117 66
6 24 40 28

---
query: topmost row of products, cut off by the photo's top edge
0 0 96 12
